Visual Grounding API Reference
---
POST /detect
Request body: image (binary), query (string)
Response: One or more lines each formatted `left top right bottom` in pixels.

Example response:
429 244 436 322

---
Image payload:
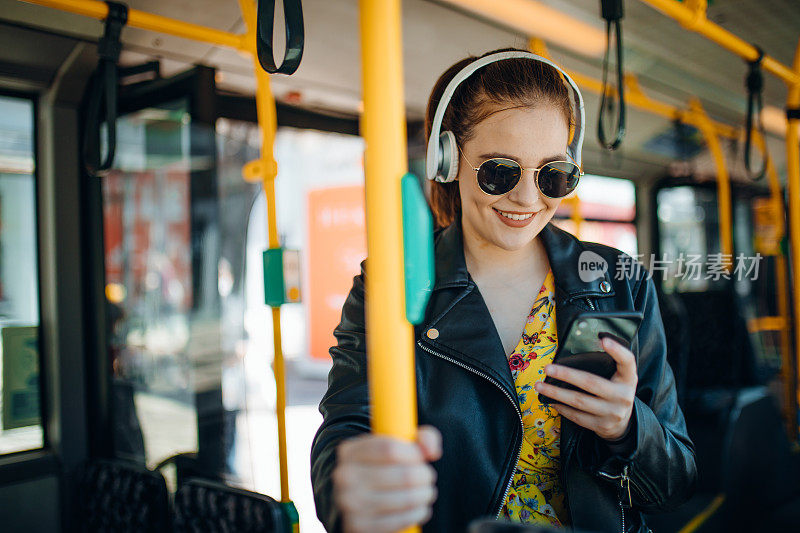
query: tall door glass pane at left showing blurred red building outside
103 103 197 466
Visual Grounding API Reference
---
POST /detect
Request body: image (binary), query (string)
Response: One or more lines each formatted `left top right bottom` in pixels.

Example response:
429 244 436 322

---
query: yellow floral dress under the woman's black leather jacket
500 270 569 526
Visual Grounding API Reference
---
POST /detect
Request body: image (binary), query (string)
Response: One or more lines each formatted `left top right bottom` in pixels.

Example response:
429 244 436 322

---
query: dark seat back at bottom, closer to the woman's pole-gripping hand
173 479 289 533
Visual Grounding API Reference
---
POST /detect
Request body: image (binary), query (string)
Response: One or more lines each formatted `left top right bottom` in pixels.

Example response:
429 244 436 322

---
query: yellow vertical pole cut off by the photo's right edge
786 40 800 420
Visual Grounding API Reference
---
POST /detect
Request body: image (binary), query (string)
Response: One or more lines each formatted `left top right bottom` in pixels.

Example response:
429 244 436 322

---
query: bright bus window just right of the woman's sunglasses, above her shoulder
553 174 638 256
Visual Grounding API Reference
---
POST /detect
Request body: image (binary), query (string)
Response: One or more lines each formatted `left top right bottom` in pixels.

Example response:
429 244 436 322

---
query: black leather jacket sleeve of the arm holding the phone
592 268 697 512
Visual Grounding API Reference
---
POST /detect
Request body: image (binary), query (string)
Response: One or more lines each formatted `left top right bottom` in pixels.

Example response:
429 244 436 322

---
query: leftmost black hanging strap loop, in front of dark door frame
83 1 128 175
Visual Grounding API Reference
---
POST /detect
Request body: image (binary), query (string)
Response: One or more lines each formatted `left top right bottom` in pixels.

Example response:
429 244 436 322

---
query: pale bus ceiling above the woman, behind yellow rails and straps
3 0 800 181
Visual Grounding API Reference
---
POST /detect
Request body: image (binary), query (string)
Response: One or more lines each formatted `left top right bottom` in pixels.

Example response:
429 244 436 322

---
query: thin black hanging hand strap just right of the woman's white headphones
597 0 625 150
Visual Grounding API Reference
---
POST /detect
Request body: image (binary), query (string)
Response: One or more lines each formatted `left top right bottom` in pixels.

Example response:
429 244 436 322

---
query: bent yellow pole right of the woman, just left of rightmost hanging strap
689 98 733 272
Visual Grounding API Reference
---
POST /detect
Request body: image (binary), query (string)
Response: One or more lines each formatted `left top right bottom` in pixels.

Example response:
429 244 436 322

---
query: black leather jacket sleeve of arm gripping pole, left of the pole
311 263 371 532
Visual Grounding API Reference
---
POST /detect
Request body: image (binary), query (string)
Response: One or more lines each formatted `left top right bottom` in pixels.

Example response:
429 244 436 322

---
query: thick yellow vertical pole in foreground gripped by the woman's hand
360 0 417 516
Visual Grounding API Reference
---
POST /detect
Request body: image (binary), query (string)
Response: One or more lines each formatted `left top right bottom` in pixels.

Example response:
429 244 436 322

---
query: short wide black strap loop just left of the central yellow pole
256 0 305 75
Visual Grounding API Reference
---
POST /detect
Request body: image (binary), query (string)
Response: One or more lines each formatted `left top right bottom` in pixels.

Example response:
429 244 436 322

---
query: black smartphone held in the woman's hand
539 311 643 403
